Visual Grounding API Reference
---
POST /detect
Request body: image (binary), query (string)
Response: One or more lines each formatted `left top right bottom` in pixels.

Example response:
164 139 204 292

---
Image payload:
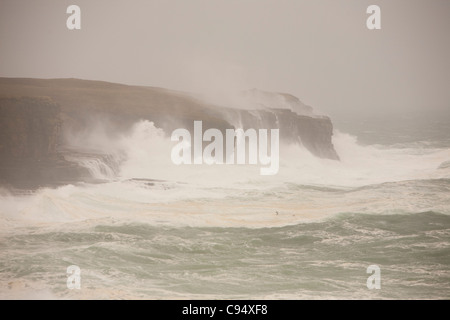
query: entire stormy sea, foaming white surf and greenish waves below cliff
0 115 450 299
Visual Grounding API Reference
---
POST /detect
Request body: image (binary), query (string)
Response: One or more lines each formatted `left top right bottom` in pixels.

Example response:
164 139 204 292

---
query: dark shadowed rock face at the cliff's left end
0 97 86 188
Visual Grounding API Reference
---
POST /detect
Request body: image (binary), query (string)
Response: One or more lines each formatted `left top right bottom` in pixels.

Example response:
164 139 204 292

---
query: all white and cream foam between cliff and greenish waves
0 121 450 232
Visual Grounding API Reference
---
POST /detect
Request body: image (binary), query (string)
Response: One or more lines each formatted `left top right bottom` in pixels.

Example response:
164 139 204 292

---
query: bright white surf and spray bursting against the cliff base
111 121 450 187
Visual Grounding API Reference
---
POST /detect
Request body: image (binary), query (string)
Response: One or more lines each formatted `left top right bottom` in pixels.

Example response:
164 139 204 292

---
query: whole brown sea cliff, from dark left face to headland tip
0 78 339 186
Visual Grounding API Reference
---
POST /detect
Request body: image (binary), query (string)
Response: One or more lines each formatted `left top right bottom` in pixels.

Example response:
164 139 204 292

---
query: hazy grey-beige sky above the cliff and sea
0 0 450 115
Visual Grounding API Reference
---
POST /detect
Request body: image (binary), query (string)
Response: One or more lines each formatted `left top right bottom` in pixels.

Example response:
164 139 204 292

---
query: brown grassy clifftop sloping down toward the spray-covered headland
0 78 229 132
